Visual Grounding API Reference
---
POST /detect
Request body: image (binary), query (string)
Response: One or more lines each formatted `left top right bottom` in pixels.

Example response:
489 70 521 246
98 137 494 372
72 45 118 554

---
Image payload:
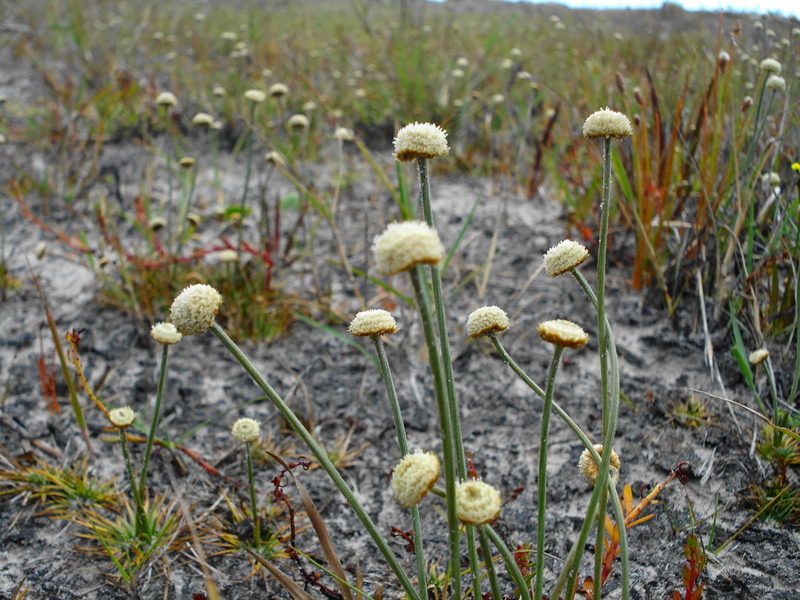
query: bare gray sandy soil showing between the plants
0 7 800 600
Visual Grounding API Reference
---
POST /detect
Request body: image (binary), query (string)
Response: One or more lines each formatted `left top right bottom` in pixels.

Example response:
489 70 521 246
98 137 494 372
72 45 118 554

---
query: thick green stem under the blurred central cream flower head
408 265 461 600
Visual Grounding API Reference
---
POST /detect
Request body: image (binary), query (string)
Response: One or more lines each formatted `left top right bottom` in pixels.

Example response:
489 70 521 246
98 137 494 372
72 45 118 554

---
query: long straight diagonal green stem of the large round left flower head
211 323 422 600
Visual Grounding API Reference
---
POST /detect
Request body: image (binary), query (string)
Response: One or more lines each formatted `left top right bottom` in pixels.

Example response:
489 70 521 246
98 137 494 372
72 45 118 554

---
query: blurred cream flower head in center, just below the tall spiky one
372 221 444 275
